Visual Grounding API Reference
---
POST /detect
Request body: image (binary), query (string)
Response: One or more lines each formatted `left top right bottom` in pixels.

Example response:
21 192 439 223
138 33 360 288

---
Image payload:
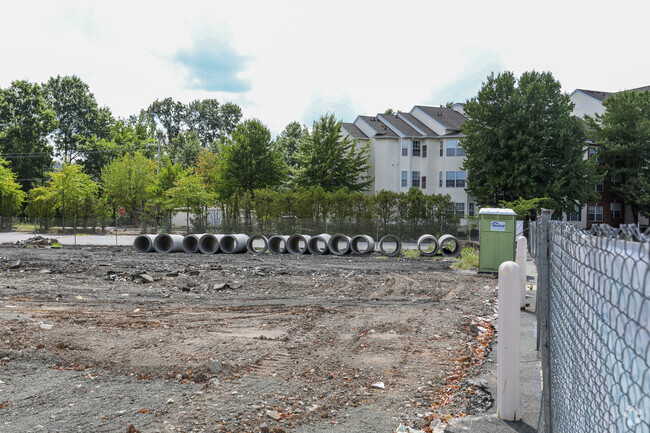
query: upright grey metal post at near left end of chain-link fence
535 209 553 433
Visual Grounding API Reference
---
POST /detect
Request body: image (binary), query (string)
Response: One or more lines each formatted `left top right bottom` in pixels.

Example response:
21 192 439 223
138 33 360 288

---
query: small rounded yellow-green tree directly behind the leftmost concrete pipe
101 153 156 218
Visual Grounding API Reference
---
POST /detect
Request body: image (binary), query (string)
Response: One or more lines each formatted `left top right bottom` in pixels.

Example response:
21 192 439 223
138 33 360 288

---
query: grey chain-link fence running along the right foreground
529 211 650 433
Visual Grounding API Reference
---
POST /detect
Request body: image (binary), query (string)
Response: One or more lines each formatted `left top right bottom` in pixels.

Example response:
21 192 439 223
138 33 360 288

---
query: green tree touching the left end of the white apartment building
290 114 372 192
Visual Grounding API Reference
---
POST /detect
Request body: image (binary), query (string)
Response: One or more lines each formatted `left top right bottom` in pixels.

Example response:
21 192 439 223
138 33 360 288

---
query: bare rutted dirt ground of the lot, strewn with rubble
0 245 496 433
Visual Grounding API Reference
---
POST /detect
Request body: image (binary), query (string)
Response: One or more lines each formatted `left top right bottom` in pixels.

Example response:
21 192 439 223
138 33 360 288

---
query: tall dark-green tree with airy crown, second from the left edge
44 75 113 162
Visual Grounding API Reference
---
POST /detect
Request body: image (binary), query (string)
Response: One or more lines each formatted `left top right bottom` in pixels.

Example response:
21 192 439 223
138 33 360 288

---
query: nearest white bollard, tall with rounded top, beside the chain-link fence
497 262 520 421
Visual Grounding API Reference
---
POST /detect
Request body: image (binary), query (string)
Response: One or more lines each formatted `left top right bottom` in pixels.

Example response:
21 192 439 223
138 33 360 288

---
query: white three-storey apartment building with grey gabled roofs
343 104 477 224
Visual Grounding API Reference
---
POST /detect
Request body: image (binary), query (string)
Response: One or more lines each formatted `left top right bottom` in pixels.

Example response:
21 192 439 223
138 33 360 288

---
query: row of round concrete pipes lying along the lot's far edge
133 233 460 257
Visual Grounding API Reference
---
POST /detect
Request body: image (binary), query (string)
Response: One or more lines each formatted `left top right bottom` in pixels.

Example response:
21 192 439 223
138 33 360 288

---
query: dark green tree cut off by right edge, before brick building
587 91 650 222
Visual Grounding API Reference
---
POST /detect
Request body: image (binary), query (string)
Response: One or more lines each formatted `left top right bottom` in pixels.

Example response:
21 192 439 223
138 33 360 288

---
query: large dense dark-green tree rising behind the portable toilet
462 71 598 212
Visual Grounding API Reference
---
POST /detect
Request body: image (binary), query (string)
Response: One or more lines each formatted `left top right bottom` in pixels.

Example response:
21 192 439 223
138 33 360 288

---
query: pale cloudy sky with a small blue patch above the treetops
0 0 650 135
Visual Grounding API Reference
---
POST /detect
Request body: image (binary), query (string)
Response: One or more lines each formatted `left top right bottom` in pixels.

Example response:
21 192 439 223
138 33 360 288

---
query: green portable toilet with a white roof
478 208 517 272
